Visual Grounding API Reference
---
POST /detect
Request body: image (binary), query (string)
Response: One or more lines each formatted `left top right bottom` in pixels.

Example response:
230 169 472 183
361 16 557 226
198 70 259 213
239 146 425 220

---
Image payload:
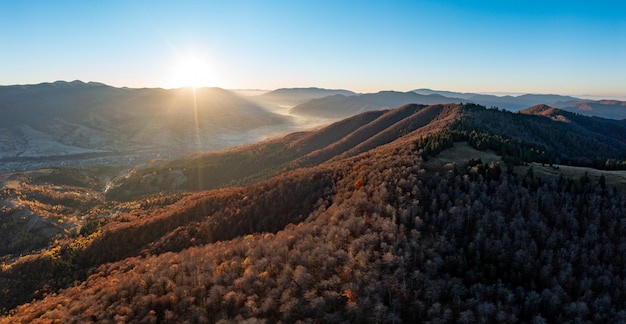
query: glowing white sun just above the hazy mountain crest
171 56 215 88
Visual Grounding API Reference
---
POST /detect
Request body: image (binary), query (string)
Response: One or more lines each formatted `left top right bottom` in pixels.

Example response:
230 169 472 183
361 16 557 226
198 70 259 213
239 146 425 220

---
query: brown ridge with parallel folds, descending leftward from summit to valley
106 104 461 200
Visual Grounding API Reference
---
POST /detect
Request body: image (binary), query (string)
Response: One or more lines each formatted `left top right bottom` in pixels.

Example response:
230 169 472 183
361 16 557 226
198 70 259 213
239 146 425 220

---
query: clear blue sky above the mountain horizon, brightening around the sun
0 0 626 97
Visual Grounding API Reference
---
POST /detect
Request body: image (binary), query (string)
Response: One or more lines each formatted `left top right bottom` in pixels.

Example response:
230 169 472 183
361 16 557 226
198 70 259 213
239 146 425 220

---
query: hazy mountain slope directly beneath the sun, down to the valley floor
0 81 290 171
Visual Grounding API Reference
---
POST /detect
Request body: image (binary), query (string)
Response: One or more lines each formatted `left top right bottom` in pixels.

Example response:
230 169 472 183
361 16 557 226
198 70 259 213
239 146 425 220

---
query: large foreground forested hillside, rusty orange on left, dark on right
0 104 626 323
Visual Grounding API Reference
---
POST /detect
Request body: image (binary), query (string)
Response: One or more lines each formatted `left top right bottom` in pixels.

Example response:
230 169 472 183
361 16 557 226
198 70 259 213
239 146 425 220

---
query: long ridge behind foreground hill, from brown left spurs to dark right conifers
106 104 626 200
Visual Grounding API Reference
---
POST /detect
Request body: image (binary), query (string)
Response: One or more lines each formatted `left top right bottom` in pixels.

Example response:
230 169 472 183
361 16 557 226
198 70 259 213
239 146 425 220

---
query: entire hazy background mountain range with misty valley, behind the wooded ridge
0 81 626 175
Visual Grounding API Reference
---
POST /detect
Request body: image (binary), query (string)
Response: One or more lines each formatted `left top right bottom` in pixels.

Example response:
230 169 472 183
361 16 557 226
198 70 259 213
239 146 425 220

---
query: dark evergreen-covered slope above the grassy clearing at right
450 104 626 170
